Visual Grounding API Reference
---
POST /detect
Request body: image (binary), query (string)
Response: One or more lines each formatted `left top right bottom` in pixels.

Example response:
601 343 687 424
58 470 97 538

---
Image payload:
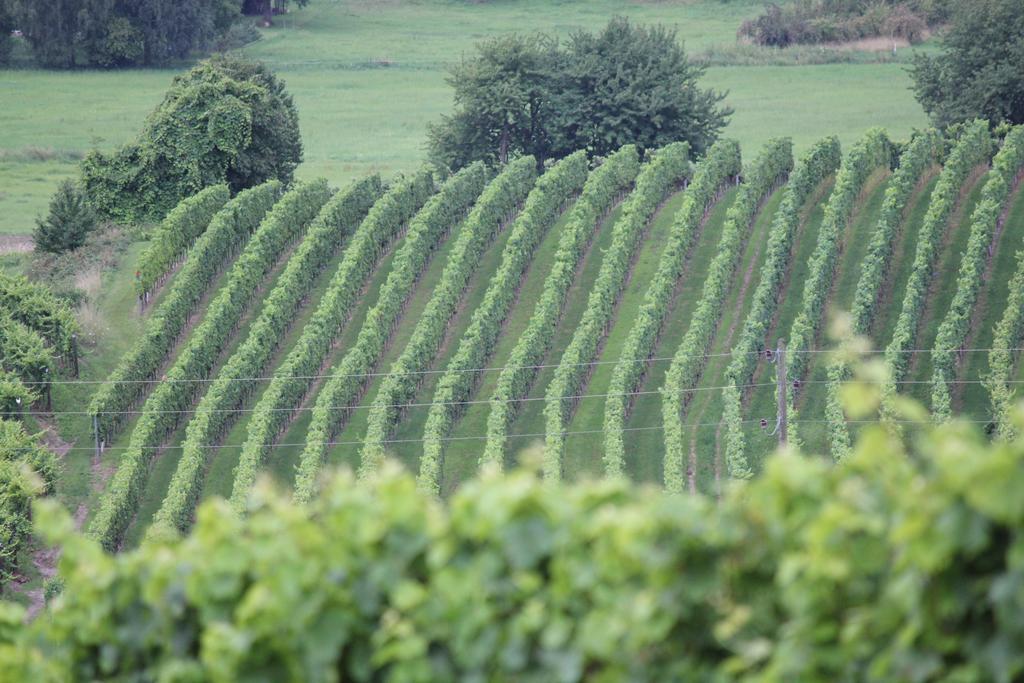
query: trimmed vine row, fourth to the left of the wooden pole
544 142 692 479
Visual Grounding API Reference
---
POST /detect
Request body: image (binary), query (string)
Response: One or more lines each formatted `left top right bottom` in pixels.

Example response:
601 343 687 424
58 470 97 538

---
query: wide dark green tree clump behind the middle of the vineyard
428 18 731 169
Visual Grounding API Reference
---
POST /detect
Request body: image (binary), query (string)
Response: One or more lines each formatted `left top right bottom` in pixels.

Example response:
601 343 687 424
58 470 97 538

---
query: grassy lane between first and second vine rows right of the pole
786 168 891 453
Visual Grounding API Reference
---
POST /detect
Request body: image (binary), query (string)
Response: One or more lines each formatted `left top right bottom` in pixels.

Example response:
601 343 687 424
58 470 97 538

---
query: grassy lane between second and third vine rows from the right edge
898 166 987 405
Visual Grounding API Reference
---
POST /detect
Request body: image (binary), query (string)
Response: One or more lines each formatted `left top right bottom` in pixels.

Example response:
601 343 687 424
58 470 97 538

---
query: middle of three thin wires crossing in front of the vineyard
6 379 1024 417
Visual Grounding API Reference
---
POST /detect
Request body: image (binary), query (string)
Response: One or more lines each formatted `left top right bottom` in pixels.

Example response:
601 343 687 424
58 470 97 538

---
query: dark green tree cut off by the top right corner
911 0 1024 127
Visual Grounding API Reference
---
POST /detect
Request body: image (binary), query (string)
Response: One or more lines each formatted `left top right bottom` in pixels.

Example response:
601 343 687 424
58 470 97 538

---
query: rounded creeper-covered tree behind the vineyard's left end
82 55 302 221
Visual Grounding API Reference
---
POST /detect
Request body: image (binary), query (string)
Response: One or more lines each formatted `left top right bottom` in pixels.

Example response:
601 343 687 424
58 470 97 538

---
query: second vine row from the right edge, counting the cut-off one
932 126 1024 420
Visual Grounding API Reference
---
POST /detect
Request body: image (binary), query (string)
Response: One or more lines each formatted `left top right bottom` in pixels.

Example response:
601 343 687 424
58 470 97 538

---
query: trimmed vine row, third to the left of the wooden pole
604 139 742 476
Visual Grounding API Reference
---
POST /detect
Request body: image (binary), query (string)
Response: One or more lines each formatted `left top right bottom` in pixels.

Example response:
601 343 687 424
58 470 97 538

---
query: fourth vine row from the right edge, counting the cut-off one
825 129 942 462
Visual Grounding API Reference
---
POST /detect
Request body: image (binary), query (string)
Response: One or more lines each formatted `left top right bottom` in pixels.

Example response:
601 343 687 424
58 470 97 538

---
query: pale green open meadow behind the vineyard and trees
0 0 926 233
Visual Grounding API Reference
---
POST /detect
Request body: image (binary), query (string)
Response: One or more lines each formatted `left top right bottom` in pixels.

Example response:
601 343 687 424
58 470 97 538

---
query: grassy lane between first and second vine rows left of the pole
677 187 784 493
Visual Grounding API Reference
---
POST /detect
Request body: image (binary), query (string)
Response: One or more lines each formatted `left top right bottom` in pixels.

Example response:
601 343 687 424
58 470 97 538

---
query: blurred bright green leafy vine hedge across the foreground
12 409 1024 683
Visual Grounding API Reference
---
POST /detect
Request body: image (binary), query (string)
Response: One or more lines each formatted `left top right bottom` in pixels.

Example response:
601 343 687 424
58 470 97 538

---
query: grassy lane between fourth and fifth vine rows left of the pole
501 203 622 476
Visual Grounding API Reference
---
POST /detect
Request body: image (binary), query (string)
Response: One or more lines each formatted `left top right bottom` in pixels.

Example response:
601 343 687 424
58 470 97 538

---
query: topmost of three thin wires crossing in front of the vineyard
22 347 1024 386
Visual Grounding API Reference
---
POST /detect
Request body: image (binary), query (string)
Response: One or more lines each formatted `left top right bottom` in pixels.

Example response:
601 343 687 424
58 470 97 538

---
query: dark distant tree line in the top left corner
0 0 308 69
